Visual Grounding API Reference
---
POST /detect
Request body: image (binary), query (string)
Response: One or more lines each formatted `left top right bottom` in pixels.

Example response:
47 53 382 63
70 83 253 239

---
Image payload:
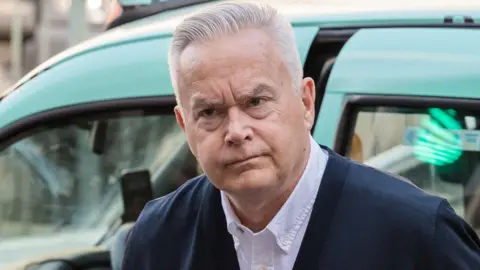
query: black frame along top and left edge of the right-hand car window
334 94 480 156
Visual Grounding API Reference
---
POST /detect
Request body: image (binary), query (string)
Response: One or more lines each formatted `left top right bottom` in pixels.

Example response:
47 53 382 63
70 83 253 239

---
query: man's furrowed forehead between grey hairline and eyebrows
177 29 288 106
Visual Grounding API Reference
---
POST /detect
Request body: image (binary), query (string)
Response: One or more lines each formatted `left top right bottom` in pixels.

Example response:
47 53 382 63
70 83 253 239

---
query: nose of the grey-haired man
225 107 253 146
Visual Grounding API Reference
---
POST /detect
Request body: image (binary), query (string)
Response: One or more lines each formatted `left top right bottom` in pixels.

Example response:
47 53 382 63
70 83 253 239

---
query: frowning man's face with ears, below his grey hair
175 29 315 194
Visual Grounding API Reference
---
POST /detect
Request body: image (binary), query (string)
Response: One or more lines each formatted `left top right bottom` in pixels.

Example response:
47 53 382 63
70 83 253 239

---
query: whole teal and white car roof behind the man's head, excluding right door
0 0 480 127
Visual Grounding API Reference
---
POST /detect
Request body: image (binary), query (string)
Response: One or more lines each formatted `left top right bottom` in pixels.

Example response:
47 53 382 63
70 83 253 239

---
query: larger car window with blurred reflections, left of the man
0 111 199 268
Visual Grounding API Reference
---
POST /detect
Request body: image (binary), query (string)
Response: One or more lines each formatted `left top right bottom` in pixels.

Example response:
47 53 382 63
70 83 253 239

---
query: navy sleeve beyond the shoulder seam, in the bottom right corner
432 200 480 270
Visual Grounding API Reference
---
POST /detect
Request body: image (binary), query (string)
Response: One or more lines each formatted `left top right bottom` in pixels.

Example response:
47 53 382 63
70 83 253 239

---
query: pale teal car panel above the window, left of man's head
0 39 173 129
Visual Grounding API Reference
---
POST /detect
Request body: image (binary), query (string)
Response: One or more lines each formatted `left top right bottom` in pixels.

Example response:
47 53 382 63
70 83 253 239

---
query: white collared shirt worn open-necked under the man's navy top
221 137 328 270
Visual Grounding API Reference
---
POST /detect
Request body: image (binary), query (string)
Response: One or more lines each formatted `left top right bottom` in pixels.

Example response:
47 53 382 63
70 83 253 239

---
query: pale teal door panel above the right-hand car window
327 28 480 98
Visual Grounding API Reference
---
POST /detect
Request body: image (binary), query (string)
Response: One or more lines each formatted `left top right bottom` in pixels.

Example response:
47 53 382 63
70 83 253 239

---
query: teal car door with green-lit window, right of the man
317 27 480 236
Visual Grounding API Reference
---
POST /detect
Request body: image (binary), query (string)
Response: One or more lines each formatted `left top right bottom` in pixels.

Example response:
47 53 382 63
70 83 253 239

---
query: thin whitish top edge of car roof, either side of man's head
0 0 480 98
